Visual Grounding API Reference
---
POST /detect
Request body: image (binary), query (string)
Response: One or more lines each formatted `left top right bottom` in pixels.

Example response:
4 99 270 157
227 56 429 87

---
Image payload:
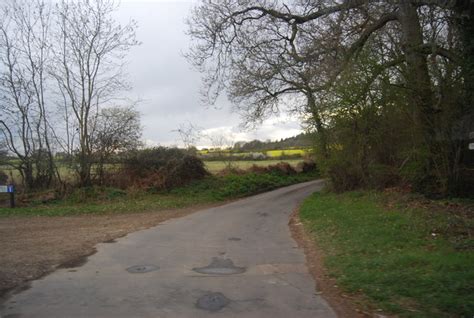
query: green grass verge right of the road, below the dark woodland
301 192 474 317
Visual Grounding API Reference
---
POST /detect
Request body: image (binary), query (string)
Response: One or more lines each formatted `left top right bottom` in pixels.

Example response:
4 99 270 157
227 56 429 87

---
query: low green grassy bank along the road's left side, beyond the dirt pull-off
0 172 318 217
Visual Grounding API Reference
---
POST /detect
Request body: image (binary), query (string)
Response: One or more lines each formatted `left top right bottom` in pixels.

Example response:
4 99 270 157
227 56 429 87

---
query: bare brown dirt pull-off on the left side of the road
0 206 222 298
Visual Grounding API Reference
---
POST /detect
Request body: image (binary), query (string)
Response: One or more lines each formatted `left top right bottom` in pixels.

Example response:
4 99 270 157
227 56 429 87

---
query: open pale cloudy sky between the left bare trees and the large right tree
117 0 300 147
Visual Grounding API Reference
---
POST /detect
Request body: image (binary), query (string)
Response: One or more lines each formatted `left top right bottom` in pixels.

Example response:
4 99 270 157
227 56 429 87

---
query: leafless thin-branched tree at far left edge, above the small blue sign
0 0 57 188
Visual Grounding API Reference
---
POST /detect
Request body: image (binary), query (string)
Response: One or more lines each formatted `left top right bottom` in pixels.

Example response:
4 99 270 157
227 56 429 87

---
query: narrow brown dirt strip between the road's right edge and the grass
288 209 374 318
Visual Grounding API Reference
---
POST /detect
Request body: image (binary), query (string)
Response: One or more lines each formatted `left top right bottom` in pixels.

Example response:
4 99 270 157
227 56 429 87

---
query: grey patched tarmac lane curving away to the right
0 181 336 318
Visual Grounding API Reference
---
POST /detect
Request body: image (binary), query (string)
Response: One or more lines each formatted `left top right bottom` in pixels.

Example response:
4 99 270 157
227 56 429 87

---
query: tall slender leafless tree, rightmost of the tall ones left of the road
52 0 139 186
